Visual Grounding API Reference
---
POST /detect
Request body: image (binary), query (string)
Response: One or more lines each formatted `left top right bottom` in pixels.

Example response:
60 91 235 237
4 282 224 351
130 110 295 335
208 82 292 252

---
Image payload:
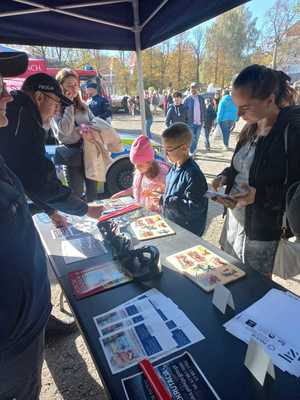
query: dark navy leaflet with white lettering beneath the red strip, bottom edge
122 352 220 400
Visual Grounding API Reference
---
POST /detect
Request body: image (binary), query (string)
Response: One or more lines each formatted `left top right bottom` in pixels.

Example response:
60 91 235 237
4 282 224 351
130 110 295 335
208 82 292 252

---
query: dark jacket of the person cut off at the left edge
0 156 51 356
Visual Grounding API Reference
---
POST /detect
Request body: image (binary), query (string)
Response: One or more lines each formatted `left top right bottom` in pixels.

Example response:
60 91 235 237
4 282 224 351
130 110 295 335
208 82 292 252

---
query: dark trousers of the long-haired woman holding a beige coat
64 166 97 201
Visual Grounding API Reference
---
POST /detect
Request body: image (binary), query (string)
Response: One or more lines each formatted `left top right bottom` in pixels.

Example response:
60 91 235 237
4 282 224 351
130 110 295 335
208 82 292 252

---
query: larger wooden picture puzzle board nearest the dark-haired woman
167 245 246 292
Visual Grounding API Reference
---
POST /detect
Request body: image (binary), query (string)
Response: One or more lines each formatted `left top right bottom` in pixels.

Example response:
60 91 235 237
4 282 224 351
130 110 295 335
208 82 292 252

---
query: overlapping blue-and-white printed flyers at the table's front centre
94 289 204 374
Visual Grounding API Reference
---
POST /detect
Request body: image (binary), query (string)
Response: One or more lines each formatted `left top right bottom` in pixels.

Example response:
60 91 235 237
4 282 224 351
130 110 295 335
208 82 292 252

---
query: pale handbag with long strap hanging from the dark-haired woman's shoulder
273 126 300 279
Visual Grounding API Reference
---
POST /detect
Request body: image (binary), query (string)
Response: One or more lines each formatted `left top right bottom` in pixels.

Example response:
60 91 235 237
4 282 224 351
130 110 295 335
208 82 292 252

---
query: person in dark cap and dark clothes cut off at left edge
0 53 51 400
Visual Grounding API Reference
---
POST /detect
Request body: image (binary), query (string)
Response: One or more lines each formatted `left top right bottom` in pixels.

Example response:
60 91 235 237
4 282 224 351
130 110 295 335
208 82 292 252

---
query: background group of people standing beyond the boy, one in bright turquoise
127 82 238 155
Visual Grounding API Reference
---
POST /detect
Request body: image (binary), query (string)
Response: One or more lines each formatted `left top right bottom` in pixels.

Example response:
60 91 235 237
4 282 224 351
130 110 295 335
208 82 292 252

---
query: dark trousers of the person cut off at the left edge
0 329 45 400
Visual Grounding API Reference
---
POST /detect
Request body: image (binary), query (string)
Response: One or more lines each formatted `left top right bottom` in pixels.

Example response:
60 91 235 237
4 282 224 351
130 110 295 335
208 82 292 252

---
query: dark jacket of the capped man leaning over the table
0 91 87 215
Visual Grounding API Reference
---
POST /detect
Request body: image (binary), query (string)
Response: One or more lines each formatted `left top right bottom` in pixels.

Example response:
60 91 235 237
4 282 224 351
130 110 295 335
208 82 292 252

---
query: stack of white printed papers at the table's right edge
224 289 300 378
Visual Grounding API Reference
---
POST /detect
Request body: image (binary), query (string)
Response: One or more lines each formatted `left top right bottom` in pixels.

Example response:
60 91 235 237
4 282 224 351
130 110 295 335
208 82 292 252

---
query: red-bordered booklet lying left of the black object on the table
68 262 131 299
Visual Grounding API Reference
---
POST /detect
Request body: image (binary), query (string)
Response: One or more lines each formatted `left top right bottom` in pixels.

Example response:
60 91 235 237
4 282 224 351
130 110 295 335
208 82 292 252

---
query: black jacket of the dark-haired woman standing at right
221 107 300 241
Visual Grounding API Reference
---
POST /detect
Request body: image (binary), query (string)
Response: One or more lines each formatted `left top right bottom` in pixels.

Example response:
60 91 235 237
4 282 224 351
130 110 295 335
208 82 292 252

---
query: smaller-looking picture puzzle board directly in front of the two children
130 214 175 240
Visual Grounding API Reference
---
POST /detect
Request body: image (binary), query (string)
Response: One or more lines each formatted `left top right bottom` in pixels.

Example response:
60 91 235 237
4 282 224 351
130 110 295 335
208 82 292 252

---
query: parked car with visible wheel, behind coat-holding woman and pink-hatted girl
46 133 164 196
